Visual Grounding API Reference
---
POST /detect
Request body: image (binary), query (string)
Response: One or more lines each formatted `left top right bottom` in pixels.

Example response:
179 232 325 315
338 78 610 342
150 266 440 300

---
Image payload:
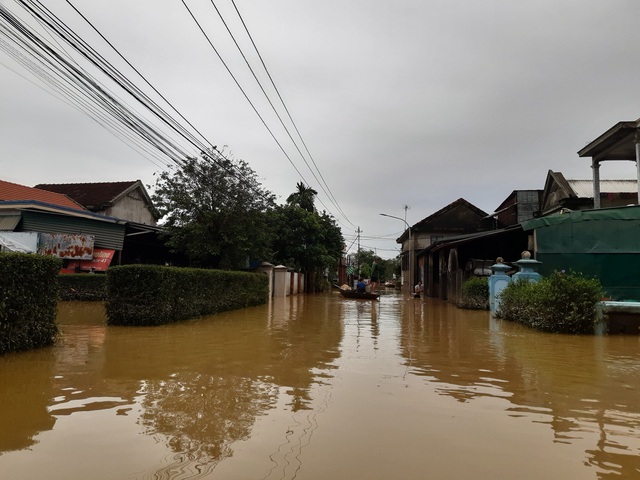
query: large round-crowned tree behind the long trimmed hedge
153 152 275 268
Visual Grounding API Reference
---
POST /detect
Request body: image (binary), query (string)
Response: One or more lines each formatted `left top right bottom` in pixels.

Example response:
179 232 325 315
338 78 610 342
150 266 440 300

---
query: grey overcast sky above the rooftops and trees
0 0 640 258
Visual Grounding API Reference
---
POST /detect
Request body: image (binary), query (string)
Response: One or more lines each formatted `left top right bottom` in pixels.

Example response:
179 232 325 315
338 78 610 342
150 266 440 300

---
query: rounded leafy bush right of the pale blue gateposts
496 271 603 333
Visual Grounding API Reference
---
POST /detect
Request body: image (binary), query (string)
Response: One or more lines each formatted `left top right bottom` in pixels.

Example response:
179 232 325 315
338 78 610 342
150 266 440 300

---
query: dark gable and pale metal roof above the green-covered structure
536 170 638 217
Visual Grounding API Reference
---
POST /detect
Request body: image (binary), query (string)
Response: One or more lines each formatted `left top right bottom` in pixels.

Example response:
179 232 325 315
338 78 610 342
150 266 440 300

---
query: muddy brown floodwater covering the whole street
0 292 640 480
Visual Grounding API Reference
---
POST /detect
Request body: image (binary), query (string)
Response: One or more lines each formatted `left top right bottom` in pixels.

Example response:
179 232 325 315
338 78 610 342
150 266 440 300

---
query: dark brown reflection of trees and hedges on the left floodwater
0 296 342 473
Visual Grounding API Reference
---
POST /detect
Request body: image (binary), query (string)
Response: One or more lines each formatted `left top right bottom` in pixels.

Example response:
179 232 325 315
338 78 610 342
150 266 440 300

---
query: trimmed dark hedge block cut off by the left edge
0 253 62 354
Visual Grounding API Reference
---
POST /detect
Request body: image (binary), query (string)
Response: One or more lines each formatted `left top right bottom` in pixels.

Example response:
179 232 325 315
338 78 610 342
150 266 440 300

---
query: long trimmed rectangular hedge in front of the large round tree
106 265 269 325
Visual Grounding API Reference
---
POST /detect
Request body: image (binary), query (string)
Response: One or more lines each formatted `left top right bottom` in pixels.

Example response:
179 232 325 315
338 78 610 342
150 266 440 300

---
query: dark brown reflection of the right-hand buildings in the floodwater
400 299 640 479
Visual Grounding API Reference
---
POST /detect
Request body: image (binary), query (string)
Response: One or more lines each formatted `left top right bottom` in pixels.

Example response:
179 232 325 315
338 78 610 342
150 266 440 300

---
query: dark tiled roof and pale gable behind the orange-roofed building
35 180 157 226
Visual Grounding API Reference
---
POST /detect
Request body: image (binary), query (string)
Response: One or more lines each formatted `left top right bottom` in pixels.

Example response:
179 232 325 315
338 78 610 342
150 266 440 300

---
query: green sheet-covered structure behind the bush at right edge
522 205 640 301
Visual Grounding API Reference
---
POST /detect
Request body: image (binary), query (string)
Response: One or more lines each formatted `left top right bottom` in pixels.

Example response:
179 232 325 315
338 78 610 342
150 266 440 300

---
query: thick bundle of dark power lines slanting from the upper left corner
0 0 276 202
